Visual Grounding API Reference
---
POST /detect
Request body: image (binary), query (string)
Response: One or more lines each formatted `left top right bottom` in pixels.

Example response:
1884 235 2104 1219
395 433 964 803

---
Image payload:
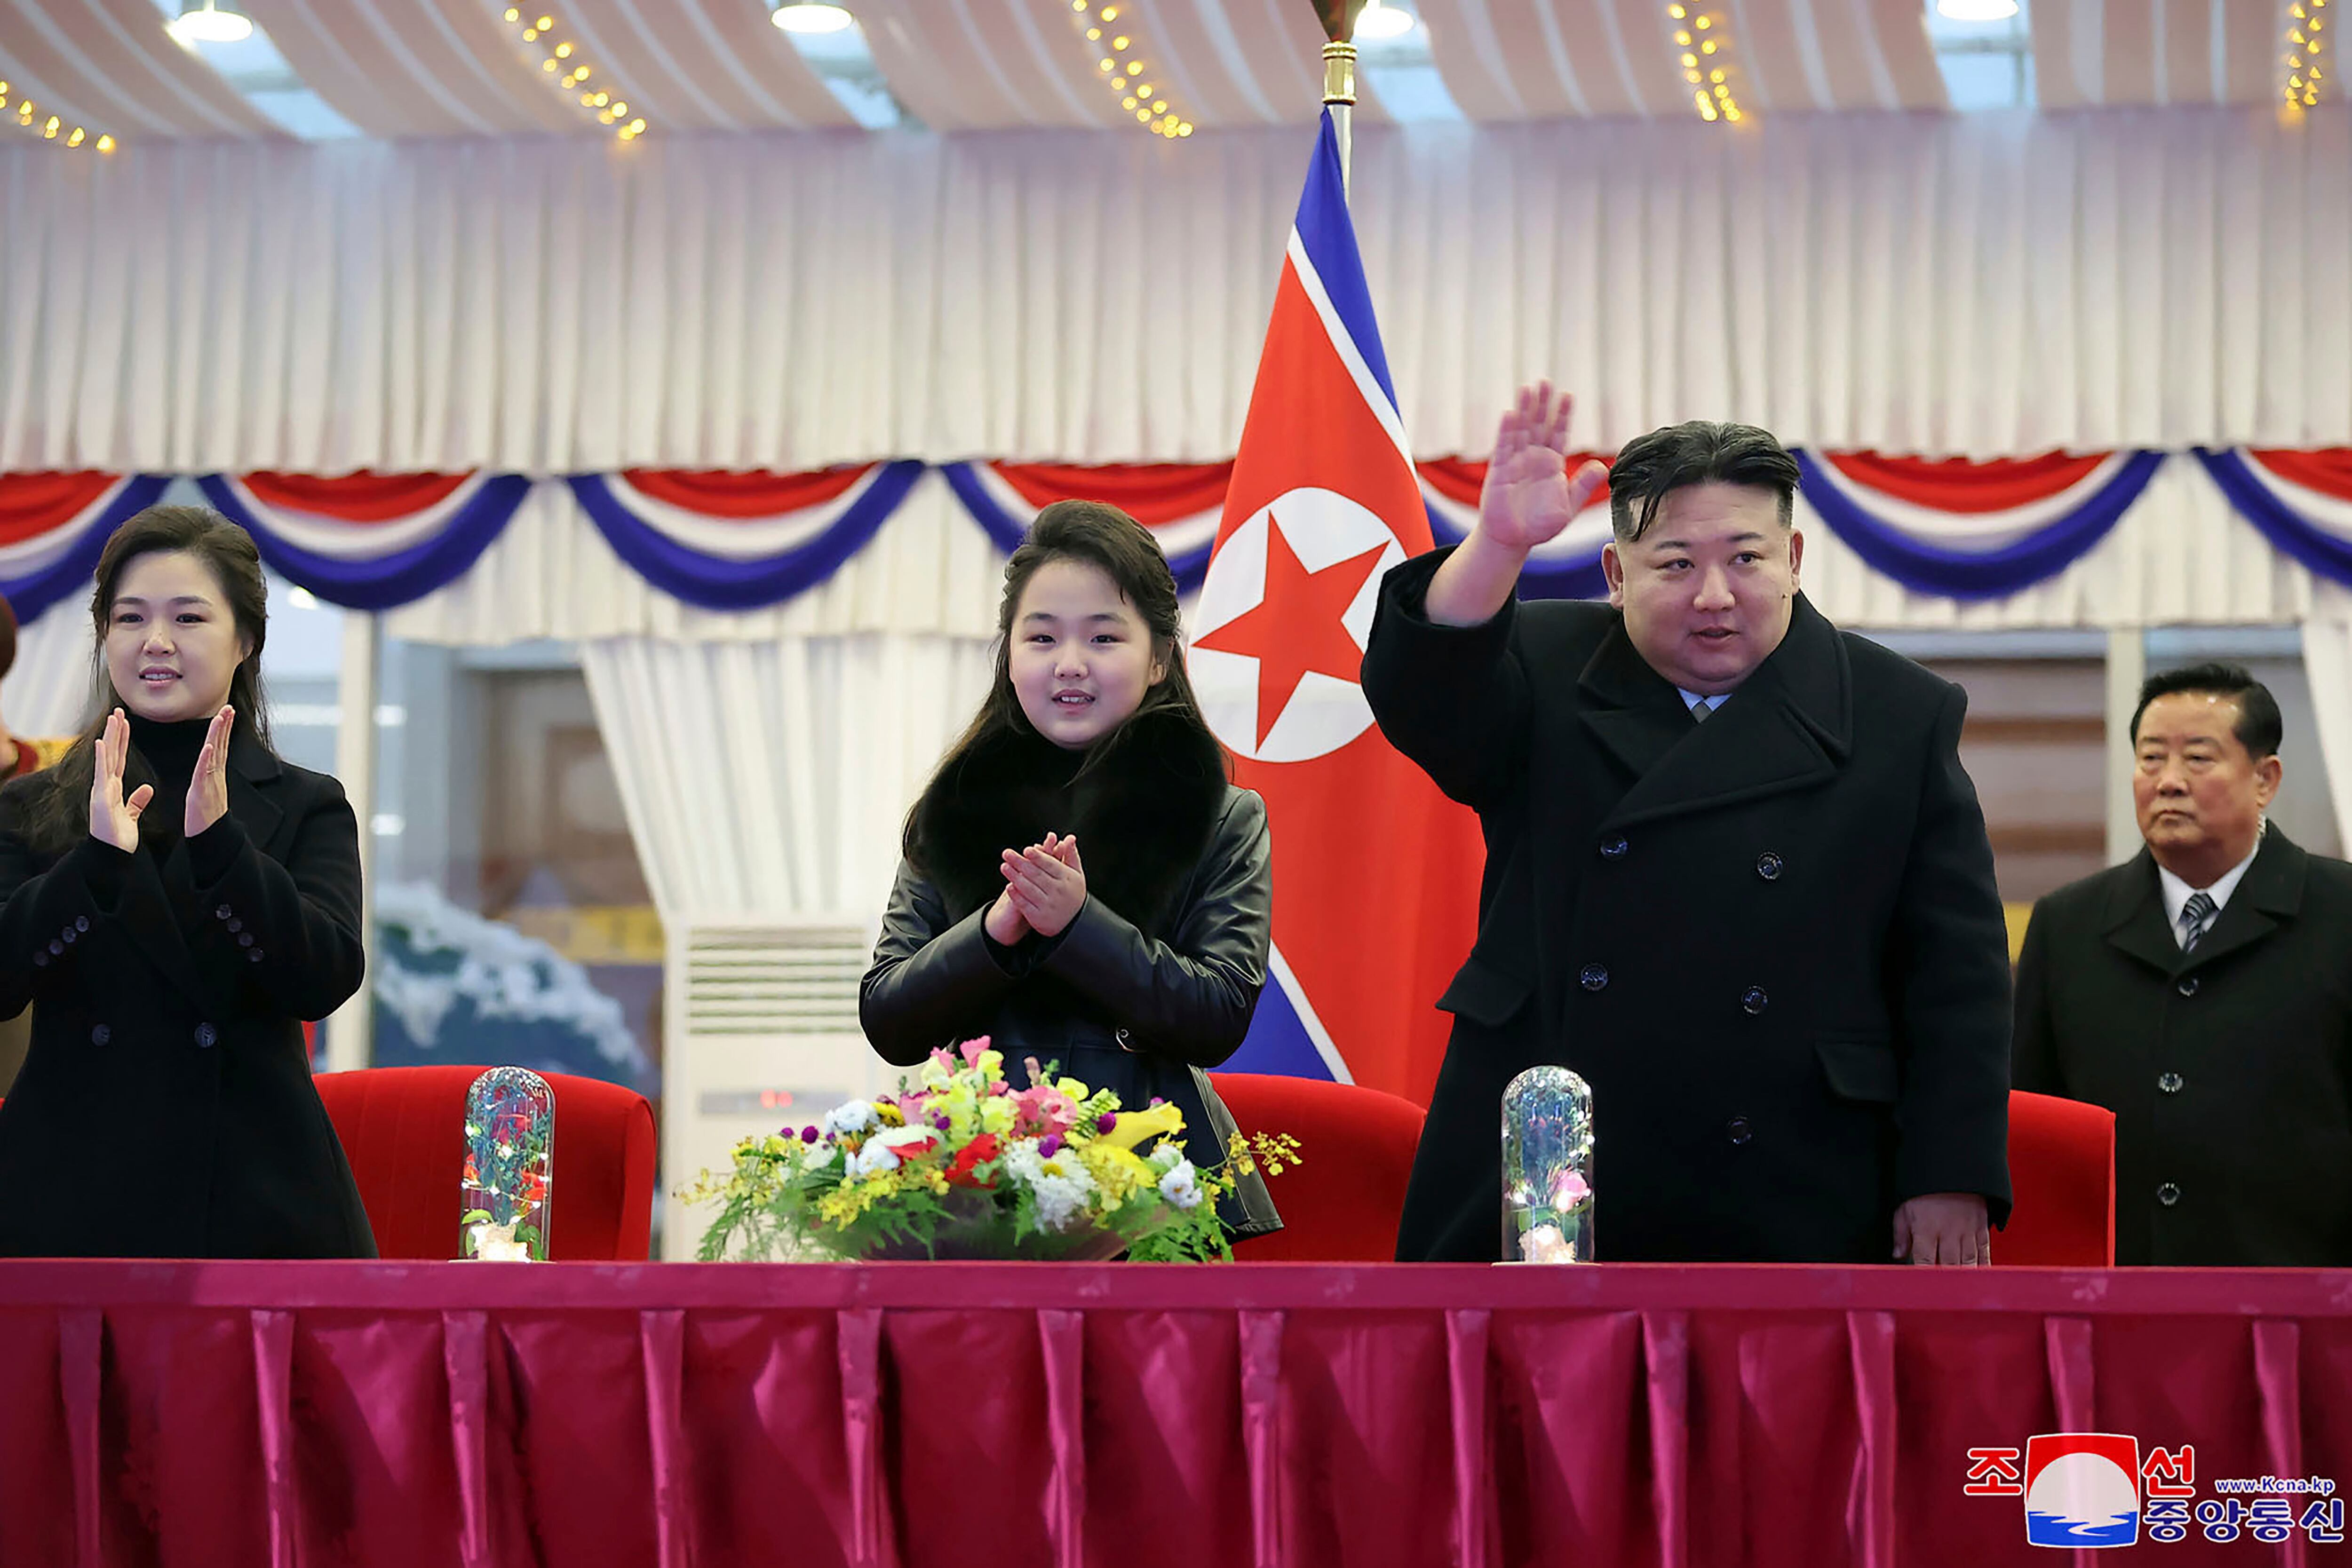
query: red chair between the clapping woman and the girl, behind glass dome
315 1065 654 1262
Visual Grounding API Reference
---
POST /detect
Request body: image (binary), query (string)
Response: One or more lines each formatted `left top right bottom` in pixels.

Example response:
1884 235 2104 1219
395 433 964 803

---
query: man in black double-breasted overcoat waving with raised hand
1364 386 2009 1262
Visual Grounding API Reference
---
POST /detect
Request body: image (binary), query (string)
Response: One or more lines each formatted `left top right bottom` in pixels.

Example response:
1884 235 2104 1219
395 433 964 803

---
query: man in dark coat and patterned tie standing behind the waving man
2016 665 2352 1267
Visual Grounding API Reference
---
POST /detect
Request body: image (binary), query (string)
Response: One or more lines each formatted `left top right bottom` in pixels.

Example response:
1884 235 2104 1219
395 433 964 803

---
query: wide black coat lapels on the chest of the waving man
1581 595 1853 827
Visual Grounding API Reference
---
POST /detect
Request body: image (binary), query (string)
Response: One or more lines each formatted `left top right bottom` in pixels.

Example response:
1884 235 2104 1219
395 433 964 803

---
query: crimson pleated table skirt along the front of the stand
0 1262 2352 1568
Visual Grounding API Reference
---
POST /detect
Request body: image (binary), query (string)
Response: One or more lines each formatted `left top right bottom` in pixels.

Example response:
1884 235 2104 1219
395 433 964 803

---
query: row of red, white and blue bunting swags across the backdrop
0 449 2352 621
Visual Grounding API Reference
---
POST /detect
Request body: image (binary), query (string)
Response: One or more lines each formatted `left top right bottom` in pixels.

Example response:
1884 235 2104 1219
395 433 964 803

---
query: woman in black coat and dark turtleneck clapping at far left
0 506 376 1258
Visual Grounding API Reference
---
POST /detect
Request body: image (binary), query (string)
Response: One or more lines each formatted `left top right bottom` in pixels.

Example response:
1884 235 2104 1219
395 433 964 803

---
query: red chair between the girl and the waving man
1209 1072 1421 1262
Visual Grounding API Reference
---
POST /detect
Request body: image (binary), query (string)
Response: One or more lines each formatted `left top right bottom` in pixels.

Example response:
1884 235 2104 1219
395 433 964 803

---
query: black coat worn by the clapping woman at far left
0 729 374 1258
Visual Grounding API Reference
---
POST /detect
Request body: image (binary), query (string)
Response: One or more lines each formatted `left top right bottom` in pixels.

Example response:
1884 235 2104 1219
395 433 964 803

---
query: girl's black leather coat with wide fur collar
858 715 1282 1236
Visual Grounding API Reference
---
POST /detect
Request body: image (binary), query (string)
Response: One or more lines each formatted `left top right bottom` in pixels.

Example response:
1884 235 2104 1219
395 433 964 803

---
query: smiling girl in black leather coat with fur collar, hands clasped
858 501 1282 1236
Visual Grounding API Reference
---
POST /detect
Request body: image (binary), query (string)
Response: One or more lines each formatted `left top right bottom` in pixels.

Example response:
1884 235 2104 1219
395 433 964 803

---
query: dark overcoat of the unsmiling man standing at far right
2016 827 2352 1269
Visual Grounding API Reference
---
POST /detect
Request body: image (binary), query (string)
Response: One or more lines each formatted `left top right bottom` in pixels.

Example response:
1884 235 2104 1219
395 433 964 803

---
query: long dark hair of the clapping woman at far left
26 506 270 853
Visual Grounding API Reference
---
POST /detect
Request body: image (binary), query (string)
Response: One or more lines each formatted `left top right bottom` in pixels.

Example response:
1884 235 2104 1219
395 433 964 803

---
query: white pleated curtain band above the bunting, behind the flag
0 103 2352 475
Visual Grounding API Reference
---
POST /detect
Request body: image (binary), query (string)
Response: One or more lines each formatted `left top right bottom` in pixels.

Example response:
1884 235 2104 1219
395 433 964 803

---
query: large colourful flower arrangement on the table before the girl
680 1039 1298 1262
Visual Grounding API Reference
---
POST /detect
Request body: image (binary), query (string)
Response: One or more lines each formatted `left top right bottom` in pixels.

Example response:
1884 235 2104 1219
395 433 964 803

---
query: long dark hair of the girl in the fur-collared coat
901 501 1209 858
